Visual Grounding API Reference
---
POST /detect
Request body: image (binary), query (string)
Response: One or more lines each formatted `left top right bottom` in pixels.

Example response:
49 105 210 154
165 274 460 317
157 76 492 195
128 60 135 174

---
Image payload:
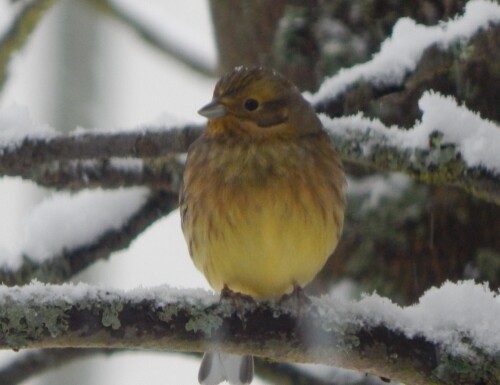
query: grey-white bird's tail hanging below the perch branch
198 352 253 385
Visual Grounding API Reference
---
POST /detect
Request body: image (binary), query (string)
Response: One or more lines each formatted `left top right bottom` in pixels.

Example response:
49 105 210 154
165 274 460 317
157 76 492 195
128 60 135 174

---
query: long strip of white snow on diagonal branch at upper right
305 0 500 104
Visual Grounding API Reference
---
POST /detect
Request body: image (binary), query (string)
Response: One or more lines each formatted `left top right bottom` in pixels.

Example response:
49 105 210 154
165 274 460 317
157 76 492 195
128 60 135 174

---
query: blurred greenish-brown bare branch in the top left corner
0 0 55 91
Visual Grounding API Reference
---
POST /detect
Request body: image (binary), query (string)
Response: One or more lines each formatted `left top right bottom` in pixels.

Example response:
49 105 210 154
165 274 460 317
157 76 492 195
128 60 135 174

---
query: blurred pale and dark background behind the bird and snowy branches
0 0 500 385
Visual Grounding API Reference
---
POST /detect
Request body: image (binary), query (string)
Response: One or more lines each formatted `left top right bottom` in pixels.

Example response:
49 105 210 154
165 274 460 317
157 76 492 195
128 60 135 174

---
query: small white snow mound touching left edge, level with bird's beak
0 103 57 149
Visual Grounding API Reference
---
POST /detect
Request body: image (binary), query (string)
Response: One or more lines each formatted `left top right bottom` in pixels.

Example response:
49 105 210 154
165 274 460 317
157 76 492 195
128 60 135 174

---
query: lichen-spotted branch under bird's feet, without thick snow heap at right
0 285 500 385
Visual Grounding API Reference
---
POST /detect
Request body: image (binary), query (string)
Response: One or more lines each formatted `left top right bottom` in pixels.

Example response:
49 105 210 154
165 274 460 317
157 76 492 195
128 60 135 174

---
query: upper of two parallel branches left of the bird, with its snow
0 105 201 164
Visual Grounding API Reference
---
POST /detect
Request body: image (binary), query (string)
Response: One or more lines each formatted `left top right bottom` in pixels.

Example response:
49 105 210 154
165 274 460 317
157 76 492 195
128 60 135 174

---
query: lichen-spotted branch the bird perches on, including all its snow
0 281 500 385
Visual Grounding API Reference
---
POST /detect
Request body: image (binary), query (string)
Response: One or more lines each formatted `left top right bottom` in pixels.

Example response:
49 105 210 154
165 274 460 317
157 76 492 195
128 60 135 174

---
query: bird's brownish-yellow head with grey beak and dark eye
198 67 321 138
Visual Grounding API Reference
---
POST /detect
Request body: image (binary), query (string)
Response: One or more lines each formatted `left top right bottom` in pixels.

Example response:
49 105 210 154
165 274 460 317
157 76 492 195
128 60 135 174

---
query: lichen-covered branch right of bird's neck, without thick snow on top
329 118 500 205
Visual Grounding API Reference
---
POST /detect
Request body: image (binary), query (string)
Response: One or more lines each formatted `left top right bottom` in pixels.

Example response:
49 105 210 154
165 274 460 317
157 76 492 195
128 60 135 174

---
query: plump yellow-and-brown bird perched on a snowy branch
180 66 346 385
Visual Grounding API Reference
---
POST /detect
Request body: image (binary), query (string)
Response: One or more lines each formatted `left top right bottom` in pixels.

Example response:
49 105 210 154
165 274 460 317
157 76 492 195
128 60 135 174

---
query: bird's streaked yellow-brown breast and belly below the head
182 134 344 297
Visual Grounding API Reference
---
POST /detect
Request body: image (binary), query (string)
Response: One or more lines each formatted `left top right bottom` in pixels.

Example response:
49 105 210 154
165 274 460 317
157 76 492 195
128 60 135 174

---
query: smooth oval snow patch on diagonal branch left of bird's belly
20 188 149 262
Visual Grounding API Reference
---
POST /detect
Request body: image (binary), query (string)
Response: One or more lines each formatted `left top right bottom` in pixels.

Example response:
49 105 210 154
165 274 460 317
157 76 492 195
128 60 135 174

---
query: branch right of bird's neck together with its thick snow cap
321 92 500 204
